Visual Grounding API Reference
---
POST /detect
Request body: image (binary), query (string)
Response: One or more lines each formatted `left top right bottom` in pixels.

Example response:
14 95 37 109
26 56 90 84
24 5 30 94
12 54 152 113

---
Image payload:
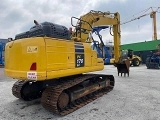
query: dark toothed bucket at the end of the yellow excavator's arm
116 59 130 76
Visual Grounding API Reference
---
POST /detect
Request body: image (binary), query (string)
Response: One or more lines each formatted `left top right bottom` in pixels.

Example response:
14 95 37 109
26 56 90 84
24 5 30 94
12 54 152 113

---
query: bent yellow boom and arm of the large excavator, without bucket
71 10 121 62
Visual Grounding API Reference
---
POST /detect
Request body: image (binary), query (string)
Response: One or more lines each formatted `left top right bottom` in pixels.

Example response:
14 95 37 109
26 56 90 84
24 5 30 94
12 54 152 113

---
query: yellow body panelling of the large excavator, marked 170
5 37 104 80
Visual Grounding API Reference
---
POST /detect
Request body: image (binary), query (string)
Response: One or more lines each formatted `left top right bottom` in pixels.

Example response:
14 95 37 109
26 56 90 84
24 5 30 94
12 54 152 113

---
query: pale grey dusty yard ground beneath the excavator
0 65 160 120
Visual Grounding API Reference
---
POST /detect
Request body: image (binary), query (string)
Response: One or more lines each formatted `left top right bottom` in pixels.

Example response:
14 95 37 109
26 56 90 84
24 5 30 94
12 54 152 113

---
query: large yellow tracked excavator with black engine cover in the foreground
5 11 129 116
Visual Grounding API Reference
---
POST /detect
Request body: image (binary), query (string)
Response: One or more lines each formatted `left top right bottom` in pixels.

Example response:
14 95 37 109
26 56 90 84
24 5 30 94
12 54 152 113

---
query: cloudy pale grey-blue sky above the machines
0 0 160 44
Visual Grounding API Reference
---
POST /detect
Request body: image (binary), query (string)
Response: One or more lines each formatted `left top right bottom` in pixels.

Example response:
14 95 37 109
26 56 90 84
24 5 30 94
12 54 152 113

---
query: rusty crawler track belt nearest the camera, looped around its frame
41 74 114 116
